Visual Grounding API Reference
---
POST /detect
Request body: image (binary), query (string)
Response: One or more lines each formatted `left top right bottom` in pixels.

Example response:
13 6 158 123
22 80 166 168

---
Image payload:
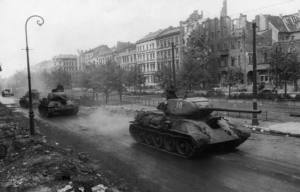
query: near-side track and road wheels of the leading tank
129 124 204 158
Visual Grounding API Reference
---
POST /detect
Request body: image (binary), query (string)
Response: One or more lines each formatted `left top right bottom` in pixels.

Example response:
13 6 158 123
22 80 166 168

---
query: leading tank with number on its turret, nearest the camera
129 98 261 158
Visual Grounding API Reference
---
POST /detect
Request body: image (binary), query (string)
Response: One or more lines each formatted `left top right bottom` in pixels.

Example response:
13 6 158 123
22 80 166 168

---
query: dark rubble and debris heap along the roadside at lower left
0 103 128 192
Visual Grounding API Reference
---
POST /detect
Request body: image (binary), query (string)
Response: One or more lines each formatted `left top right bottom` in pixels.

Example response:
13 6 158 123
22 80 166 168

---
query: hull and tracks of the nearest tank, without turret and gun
129 112 250 158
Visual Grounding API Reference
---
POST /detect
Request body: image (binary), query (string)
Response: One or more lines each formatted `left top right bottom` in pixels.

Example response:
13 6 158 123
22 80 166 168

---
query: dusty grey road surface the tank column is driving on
0 97 300 192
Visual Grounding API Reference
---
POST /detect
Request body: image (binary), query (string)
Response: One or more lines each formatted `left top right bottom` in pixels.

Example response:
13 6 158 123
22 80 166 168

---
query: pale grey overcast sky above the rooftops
0 0 300 78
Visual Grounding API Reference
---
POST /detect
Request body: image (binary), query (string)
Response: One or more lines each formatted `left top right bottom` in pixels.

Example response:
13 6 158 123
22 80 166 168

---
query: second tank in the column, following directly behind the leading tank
38 85 79 117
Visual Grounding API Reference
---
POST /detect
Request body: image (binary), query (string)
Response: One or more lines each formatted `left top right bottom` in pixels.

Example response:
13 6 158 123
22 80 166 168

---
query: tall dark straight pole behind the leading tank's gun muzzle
252 23 259 125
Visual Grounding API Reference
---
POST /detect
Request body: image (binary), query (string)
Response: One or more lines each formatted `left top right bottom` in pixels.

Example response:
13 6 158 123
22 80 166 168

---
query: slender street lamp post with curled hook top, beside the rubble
25 15 44 135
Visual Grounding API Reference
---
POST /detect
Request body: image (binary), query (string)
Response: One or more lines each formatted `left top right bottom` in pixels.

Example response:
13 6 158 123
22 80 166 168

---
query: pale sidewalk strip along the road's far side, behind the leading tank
122 104 300 137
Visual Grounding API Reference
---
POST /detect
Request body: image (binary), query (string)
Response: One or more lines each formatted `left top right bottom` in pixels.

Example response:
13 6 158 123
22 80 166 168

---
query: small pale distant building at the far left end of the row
52 55 78 76
